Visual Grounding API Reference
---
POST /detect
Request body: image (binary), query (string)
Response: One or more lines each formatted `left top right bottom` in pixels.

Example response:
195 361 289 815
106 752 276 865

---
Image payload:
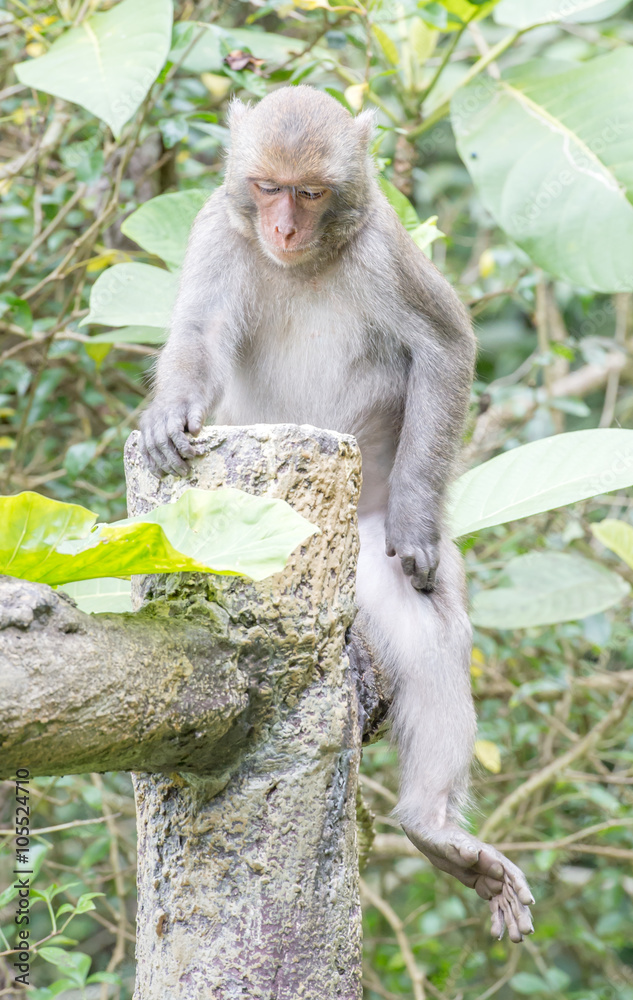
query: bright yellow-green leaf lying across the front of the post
0 489 318 585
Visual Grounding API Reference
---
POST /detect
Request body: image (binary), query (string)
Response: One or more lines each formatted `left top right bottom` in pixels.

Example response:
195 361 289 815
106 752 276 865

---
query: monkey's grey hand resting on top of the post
139 399 205 476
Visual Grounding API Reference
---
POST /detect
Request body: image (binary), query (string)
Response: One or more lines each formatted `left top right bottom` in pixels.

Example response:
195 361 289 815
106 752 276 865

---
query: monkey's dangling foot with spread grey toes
403 826 534 942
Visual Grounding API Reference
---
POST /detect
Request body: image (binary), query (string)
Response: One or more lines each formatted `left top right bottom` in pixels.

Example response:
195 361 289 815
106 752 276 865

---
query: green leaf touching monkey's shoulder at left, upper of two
121 189 209 268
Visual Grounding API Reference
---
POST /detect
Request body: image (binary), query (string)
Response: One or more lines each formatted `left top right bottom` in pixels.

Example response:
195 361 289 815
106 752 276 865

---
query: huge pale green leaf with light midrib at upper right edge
451 46 633 292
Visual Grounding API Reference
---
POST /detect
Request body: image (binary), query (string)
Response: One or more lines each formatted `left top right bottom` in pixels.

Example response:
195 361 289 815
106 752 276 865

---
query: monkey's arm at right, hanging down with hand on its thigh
385 209 475 591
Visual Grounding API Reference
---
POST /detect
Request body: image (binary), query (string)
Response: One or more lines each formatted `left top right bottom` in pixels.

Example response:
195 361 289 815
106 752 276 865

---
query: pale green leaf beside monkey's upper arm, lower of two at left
79 264 178 328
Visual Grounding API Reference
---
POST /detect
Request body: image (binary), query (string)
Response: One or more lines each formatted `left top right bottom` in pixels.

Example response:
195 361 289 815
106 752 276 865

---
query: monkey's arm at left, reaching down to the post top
140 196 242 475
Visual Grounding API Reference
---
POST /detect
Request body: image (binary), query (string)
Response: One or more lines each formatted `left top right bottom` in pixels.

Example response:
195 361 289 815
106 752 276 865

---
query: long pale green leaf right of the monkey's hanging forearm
449 428 633 538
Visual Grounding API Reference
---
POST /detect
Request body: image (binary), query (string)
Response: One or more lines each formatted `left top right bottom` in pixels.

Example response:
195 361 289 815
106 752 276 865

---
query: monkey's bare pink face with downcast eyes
251 180 332 265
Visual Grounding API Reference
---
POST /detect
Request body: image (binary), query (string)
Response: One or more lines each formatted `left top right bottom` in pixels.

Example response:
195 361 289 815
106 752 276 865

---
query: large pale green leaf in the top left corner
15 0 173 138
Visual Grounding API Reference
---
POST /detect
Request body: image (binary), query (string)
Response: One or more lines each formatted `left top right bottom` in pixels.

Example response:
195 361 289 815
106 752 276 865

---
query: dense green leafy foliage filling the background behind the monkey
0 0 633 1000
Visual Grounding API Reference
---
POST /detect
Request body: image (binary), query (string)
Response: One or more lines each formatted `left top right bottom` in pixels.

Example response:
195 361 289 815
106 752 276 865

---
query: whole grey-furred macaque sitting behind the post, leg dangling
141 86 534 941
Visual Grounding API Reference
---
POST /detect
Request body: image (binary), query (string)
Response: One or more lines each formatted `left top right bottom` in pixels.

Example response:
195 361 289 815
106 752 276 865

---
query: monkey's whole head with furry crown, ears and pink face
226 87 373 267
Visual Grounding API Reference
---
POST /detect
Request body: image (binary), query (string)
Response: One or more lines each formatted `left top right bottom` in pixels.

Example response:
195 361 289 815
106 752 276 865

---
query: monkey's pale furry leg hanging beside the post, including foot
355 512 533 941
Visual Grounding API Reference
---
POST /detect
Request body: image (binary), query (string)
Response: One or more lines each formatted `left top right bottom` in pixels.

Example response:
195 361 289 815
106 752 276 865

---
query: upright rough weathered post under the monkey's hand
126 425 362 1000
